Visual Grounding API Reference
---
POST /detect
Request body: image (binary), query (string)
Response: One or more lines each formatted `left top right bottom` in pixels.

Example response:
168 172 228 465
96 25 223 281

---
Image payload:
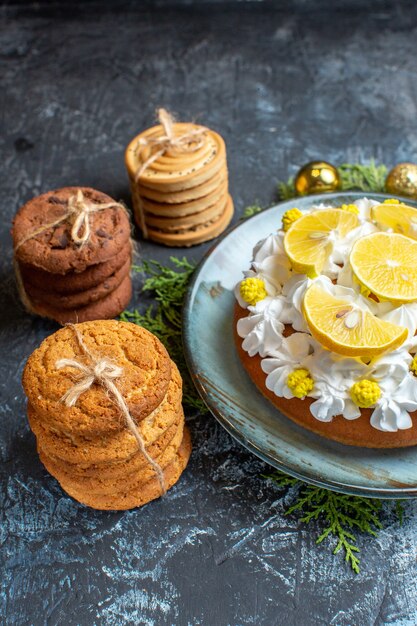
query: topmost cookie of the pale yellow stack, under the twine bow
125 123 226 192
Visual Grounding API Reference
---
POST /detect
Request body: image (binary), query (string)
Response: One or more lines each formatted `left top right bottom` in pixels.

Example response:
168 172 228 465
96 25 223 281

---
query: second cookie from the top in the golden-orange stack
28 361 182 470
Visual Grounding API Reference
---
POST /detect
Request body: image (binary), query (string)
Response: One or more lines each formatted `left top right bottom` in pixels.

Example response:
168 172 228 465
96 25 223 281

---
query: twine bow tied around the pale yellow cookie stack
135 109 208 239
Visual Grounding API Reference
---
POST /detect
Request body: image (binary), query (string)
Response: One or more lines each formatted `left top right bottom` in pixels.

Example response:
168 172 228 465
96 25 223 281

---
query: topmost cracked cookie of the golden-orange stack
22 320 171 438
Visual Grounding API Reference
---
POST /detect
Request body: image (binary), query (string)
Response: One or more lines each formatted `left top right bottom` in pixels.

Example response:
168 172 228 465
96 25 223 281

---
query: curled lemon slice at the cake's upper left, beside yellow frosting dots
284 209 359 278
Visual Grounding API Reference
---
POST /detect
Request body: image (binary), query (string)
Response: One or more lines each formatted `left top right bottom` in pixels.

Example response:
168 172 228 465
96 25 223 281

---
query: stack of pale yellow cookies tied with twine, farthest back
125 109 233 246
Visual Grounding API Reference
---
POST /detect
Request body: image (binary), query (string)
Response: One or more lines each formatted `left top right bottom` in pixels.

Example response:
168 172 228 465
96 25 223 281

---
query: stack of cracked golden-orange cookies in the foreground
23 320 191 510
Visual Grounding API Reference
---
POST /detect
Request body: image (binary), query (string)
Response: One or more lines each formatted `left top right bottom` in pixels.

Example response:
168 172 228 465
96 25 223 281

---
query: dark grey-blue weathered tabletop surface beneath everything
0 1 417 626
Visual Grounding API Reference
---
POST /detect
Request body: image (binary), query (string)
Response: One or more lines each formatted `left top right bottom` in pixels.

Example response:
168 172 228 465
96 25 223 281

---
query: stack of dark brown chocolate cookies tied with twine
12 187 132 324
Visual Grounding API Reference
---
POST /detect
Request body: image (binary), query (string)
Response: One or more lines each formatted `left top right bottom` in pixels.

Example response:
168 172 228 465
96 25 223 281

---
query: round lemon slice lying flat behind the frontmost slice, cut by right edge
349 233 417 304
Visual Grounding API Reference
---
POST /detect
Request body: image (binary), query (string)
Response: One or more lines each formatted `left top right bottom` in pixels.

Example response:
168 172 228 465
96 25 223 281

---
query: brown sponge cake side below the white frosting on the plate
233 304 417 448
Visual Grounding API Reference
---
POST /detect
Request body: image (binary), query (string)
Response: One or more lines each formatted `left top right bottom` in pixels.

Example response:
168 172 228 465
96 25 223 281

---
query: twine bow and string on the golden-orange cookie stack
55 324 166 494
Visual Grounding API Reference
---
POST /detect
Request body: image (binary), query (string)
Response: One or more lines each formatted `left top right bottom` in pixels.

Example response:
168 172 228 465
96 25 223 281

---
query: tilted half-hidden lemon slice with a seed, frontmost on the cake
303 283 408 358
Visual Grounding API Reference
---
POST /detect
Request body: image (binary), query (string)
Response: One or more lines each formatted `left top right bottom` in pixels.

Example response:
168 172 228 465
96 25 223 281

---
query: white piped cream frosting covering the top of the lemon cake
235 198 417 432
